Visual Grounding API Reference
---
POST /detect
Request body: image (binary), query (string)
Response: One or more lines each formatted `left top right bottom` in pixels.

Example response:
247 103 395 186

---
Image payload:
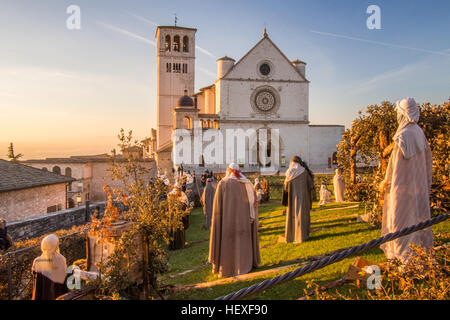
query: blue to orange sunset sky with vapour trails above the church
0 0 450 159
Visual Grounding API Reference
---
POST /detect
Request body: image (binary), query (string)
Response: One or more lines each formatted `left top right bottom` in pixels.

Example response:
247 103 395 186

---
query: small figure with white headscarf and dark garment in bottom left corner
31 234 68 300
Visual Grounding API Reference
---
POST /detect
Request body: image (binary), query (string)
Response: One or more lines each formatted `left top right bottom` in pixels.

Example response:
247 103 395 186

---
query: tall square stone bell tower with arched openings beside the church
156 26 197 149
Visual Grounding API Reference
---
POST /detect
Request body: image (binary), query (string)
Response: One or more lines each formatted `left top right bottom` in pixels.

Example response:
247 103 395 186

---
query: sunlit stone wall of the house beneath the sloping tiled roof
0 183 66 222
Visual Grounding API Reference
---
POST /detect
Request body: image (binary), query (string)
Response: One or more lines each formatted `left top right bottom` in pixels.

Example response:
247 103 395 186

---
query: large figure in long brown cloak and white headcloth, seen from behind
209 163 261 277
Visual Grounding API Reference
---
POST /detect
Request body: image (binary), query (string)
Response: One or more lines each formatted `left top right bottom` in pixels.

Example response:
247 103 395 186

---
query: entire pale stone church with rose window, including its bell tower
151 26 344 173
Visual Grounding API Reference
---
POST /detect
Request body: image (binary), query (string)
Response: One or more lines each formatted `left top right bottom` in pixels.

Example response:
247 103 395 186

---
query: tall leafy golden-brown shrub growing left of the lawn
92 129 191 299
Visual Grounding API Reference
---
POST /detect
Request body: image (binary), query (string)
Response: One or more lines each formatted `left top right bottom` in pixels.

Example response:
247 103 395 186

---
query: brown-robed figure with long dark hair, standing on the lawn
283 156 314 243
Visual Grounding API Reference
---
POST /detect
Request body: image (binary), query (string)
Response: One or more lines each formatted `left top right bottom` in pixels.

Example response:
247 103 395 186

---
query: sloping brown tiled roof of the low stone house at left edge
0 159 75 192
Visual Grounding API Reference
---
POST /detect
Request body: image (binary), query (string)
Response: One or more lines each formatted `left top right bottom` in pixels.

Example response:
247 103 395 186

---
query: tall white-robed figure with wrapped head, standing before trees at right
381 98 433 261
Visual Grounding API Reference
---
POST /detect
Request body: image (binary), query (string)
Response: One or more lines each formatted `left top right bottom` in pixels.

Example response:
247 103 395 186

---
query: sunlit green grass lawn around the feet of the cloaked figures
162 194 450 299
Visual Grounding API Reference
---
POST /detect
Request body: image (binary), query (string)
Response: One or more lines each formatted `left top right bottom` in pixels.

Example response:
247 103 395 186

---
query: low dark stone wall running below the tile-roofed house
7 202 105 240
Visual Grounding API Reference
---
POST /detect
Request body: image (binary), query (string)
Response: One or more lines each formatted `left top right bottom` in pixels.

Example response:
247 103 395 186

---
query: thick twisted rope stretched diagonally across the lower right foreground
216 213 450 300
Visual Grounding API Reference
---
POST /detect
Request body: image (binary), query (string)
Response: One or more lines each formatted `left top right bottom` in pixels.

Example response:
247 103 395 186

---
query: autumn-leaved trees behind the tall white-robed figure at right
338 101 450 222
